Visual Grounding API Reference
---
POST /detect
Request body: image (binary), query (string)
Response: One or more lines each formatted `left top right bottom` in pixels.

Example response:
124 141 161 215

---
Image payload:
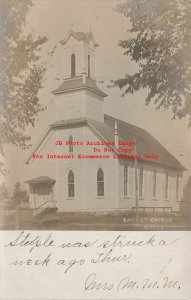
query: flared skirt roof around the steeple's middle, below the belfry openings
52 76 107 97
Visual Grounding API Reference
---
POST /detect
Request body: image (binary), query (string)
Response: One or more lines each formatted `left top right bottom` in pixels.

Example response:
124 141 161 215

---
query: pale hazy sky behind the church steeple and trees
0 0 191 190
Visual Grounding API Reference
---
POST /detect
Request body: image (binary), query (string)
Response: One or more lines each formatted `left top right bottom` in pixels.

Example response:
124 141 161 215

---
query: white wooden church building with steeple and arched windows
26 31 185 213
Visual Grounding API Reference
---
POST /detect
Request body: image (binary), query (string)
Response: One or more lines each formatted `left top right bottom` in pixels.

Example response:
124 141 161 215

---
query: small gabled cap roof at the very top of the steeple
60 30 99 47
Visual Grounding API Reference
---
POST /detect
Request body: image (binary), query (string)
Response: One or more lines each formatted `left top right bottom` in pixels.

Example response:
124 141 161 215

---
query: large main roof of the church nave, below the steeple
26 115 186 170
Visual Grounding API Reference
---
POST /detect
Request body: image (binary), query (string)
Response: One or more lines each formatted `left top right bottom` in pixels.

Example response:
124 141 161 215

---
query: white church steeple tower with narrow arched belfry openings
52 31 107 122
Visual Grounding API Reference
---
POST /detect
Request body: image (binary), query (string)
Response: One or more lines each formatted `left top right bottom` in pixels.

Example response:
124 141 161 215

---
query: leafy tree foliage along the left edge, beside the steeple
0 0 47 172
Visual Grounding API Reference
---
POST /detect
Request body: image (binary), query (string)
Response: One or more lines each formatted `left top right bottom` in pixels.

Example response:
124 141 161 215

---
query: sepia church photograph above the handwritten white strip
0 0 191 231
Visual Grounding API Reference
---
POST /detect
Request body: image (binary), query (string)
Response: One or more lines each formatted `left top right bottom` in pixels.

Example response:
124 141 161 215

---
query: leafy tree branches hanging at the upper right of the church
113 0 191 126
